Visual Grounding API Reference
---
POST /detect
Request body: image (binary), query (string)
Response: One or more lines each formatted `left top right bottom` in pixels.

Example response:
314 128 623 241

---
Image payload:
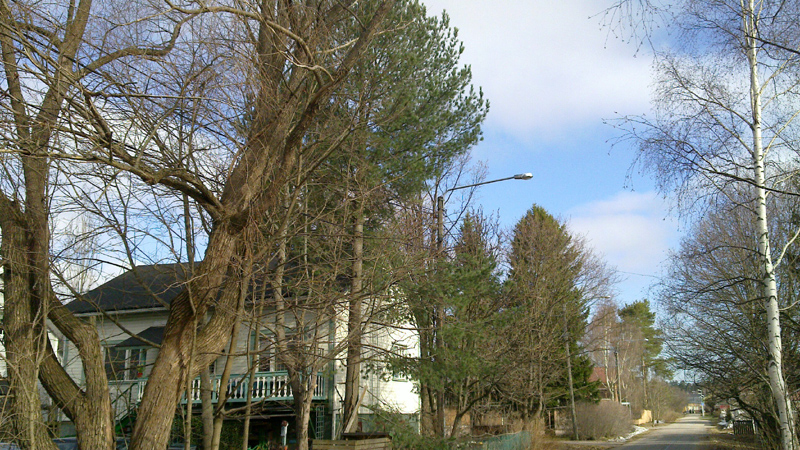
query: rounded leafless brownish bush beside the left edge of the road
575 401 633 440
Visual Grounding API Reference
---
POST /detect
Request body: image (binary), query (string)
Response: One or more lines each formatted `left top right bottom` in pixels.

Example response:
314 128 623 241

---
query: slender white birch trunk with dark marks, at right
743 0 797 450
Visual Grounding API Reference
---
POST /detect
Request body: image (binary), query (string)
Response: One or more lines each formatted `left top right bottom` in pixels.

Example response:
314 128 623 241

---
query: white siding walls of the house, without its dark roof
63 298 419 442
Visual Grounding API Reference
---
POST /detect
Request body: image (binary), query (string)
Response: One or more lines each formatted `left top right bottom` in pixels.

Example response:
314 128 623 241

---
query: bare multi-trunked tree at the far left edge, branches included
0 0 195 449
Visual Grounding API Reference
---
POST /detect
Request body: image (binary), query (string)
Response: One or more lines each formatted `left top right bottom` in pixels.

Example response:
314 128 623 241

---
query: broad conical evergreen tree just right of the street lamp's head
500 206 608 420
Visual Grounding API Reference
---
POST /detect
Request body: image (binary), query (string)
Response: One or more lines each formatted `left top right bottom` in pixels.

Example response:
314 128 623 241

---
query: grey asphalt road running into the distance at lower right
618 416 712 450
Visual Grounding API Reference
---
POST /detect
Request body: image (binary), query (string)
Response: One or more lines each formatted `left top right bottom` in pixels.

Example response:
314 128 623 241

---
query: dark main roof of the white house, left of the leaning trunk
66 264 187 314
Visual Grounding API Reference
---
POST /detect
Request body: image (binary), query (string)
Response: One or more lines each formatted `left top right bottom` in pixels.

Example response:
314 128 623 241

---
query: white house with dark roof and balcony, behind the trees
62 264 419 443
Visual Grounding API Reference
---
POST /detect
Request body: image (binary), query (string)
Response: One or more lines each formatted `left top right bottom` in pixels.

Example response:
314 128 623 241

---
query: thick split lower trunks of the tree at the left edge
0 156 114 449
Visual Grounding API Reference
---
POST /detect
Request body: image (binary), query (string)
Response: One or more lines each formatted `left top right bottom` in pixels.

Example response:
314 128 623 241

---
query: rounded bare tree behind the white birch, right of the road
659 195 798 448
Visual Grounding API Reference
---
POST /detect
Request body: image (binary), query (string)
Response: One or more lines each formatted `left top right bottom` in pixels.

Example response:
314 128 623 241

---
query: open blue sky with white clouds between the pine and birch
422 0 681 305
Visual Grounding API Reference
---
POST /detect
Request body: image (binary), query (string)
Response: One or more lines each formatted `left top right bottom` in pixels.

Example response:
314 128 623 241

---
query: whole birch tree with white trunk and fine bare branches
623 0 800 450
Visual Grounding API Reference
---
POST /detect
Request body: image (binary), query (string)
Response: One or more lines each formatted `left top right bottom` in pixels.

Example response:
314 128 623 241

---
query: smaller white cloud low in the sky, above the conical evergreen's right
568 191 679 288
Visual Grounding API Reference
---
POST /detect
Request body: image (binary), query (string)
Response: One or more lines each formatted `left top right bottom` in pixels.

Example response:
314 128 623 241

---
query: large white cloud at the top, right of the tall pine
424 0 650 139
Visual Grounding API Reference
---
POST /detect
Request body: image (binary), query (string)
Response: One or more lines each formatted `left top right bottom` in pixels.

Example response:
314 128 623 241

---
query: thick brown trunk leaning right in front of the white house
126 5 394 450
